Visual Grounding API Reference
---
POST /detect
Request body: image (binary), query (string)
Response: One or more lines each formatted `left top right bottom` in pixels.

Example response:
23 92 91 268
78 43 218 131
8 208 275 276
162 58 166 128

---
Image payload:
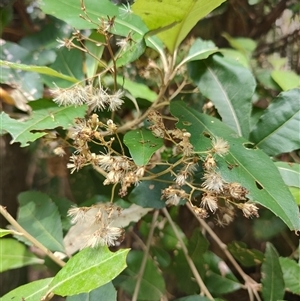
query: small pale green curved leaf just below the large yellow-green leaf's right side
180 38 218 65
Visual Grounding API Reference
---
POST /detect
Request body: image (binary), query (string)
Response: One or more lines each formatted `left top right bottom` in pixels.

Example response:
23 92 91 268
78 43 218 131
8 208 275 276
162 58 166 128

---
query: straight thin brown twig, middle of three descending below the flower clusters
162 208 214 300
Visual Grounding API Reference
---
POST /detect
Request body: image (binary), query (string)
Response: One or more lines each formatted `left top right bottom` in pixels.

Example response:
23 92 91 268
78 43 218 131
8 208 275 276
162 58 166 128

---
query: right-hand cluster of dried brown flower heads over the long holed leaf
158 132 258 226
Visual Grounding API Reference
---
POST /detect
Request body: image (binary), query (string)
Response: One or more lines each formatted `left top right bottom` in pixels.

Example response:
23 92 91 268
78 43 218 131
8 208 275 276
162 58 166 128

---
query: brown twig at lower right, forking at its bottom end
187 203 261 301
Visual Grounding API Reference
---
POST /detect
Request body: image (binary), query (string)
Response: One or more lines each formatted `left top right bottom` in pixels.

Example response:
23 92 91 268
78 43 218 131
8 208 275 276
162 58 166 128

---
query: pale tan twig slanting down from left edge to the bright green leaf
0 205 66 267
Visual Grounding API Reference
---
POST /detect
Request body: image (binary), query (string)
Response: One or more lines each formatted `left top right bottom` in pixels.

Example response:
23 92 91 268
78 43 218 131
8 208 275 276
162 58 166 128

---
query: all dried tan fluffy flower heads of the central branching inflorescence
53 81 258 247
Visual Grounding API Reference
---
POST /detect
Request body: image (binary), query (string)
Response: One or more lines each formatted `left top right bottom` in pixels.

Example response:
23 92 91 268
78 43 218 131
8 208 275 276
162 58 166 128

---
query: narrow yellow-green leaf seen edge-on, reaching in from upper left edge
0 60 78 83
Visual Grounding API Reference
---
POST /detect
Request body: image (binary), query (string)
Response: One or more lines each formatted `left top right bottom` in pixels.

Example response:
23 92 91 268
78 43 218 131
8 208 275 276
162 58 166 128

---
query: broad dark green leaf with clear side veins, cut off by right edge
250 89 300 156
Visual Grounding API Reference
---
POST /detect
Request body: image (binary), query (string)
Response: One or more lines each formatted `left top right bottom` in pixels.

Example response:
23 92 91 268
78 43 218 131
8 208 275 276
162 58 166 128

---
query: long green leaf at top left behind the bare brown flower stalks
41 0 163 53
